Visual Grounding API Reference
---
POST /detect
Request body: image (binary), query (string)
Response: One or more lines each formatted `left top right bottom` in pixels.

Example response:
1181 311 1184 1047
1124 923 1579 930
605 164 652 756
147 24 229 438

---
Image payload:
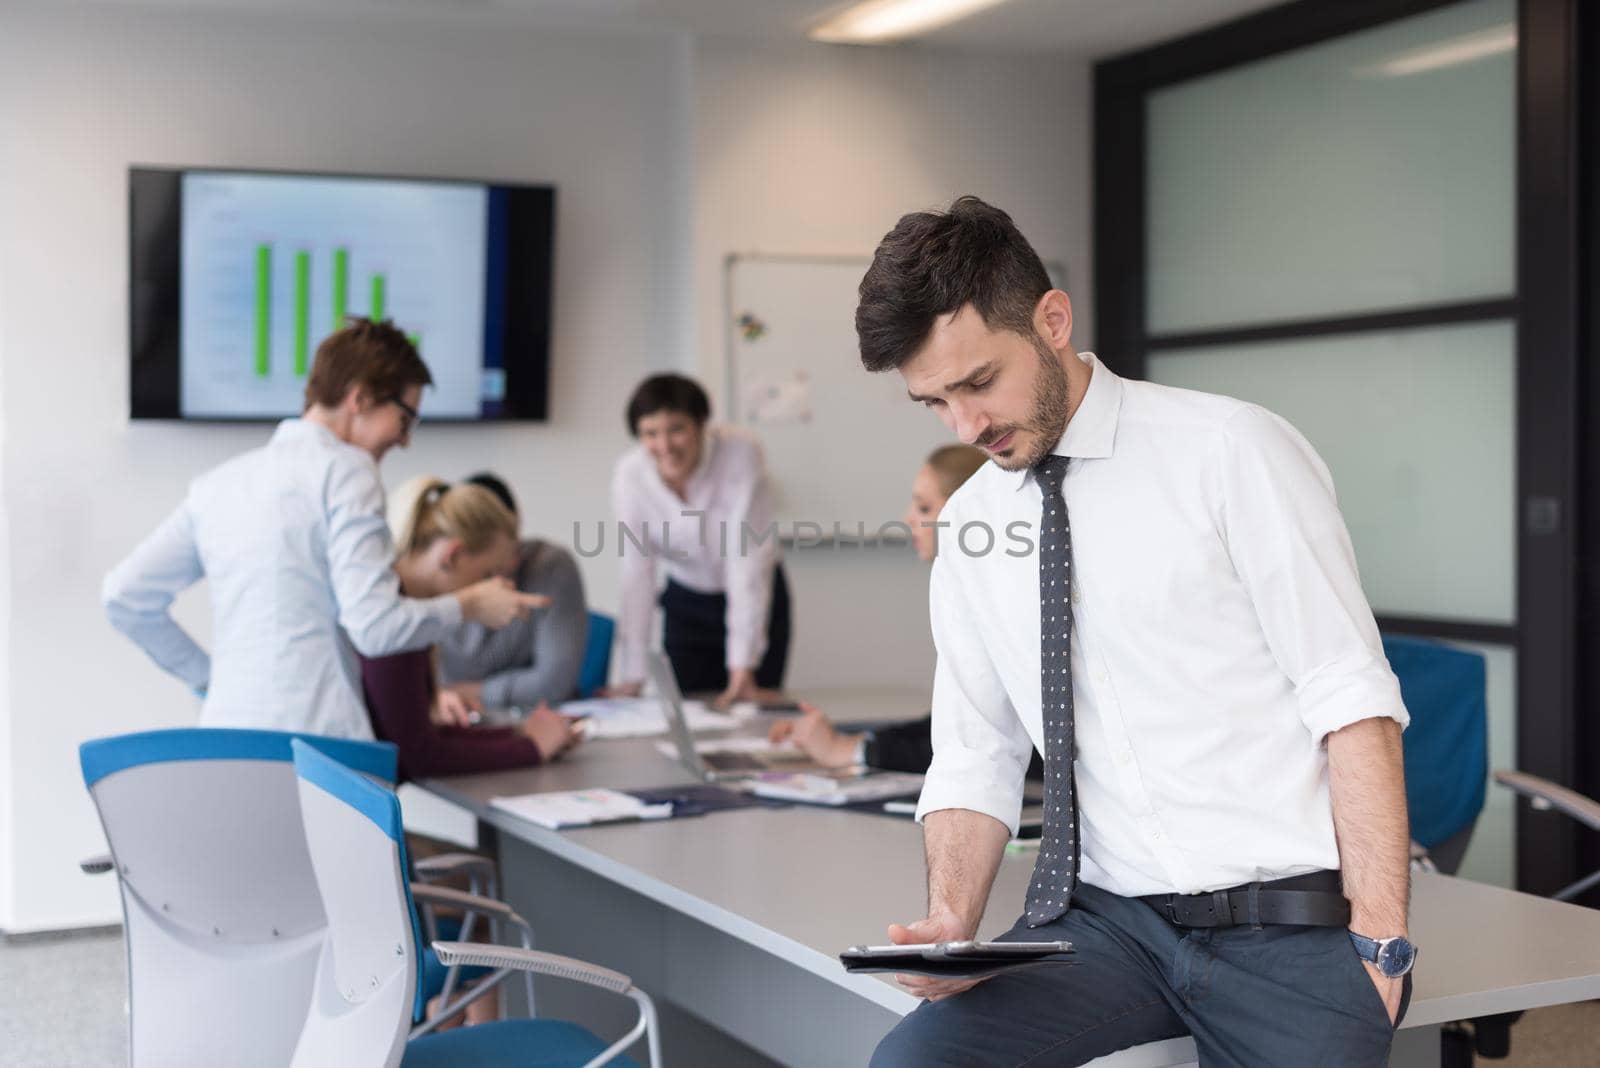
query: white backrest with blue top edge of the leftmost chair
78 727 395 1068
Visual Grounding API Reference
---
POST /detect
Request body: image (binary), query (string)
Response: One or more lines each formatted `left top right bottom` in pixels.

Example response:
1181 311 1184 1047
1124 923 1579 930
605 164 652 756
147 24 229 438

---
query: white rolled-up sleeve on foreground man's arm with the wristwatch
1221 406 1410 743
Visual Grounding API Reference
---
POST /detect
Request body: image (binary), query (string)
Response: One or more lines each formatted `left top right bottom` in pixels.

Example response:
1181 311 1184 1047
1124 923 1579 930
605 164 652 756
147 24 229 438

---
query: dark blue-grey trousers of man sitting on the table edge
872 886 1411 1068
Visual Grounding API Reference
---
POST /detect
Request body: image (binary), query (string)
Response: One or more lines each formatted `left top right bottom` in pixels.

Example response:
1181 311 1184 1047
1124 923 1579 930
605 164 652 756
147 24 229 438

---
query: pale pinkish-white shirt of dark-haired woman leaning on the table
611 427 779 683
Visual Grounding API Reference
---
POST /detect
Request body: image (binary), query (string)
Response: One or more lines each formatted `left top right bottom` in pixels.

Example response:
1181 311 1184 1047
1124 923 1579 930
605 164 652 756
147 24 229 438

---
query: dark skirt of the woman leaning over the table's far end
661 564 789 694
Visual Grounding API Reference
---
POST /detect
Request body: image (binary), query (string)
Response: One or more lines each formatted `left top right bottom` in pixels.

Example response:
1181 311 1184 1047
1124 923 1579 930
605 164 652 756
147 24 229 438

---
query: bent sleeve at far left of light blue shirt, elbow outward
101 500 211 694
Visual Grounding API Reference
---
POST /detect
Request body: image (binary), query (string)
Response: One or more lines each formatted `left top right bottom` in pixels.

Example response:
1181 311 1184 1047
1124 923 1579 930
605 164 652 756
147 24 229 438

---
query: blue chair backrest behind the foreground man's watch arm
1384 635 1490 847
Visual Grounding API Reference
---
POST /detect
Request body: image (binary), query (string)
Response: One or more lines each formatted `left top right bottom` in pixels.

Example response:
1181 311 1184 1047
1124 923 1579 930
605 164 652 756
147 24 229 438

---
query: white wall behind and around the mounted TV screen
0 8 691 931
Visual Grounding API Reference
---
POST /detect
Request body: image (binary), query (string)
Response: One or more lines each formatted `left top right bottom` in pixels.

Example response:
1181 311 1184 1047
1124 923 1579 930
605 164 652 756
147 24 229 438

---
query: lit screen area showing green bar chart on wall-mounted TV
181 173 486 419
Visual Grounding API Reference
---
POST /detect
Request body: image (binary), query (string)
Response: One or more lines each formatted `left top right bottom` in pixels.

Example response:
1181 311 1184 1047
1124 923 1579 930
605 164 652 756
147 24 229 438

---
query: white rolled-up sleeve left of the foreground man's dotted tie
917 556 1034 835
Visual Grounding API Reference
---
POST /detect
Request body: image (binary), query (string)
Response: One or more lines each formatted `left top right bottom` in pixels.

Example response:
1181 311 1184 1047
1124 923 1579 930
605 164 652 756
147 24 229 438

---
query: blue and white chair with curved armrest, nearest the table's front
288 740 661 1068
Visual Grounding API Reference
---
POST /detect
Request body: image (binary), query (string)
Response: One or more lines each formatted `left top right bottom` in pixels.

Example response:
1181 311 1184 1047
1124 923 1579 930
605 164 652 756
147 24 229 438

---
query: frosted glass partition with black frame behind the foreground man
1096 0 1578 891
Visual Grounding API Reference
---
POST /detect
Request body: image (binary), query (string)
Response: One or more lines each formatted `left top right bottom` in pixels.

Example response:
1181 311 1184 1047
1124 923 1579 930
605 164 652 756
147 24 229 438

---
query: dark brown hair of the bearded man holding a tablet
856 197 1051 371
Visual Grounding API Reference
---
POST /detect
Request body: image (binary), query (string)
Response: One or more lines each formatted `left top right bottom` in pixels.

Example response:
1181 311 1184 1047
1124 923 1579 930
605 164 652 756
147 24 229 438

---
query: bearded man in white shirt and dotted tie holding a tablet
856 197 1414 1068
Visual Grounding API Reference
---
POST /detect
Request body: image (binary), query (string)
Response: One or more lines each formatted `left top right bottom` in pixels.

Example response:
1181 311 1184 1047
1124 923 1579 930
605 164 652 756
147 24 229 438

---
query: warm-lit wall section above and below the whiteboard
694 38 1093 687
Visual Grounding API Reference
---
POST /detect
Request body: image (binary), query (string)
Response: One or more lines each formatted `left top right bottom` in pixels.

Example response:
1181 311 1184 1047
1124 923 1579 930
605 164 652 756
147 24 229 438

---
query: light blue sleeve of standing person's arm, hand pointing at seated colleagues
325 447 461 657
